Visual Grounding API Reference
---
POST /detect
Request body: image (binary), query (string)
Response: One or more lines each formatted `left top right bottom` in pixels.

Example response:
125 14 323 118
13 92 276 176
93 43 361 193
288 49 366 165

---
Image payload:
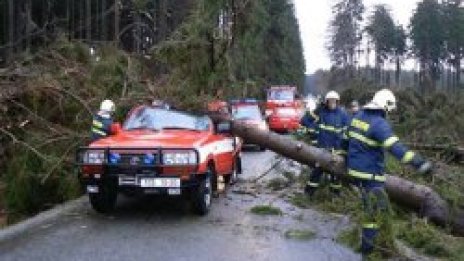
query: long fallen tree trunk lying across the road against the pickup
213 116 464 236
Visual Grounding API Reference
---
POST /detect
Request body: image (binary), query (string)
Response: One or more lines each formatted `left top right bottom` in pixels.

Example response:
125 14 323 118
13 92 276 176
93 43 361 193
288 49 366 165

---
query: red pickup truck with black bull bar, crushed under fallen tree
77 106 241 215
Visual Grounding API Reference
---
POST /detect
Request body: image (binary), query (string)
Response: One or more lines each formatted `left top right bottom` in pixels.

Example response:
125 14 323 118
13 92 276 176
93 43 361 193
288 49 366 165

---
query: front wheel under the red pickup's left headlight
89 180 118 214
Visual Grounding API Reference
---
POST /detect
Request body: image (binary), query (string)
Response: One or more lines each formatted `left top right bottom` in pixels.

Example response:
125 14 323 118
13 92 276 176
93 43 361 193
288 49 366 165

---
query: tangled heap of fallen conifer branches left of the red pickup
0 39 147 222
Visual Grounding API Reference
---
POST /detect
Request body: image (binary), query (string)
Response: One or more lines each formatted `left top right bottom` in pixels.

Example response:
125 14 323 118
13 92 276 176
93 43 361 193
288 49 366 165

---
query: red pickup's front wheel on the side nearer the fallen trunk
193 170 214 213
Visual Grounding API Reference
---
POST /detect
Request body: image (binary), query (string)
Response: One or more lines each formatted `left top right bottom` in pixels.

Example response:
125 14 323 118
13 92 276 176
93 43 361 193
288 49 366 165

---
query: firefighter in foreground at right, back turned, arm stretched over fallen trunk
347 89 432 254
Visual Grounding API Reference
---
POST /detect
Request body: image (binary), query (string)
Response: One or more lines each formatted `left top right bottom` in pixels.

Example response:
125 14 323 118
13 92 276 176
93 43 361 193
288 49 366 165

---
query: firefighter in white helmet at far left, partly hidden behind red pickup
91 100 115 141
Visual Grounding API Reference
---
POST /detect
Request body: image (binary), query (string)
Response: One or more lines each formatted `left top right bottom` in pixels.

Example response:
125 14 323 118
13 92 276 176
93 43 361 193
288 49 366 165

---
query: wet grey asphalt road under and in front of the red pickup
0 151 361 261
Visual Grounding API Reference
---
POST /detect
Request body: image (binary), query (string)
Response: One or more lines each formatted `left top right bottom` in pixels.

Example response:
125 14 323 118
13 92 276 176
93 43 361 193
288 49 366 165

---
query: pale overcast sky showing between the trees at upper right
294 0 419 73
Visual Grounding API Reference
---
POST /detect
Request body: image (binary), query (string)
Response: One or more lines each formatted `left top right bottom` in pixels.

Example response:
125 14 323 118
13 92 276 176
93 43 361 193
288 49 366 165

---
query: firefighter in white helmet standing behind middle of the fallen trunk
302 91 350 196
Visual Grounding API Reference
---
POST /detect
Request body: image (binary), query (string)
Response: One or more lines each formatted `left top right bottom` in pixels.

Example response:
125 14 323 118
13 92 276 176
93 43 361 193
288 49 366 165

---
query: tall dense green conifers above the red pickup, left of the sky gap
155 0 305 100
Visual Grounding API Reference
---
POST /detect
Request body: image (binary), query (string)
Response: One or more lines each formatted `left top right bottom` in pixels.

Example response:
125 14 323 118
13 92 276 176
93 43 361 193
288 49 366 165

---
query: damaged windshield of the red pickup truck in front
123 107 210 131
